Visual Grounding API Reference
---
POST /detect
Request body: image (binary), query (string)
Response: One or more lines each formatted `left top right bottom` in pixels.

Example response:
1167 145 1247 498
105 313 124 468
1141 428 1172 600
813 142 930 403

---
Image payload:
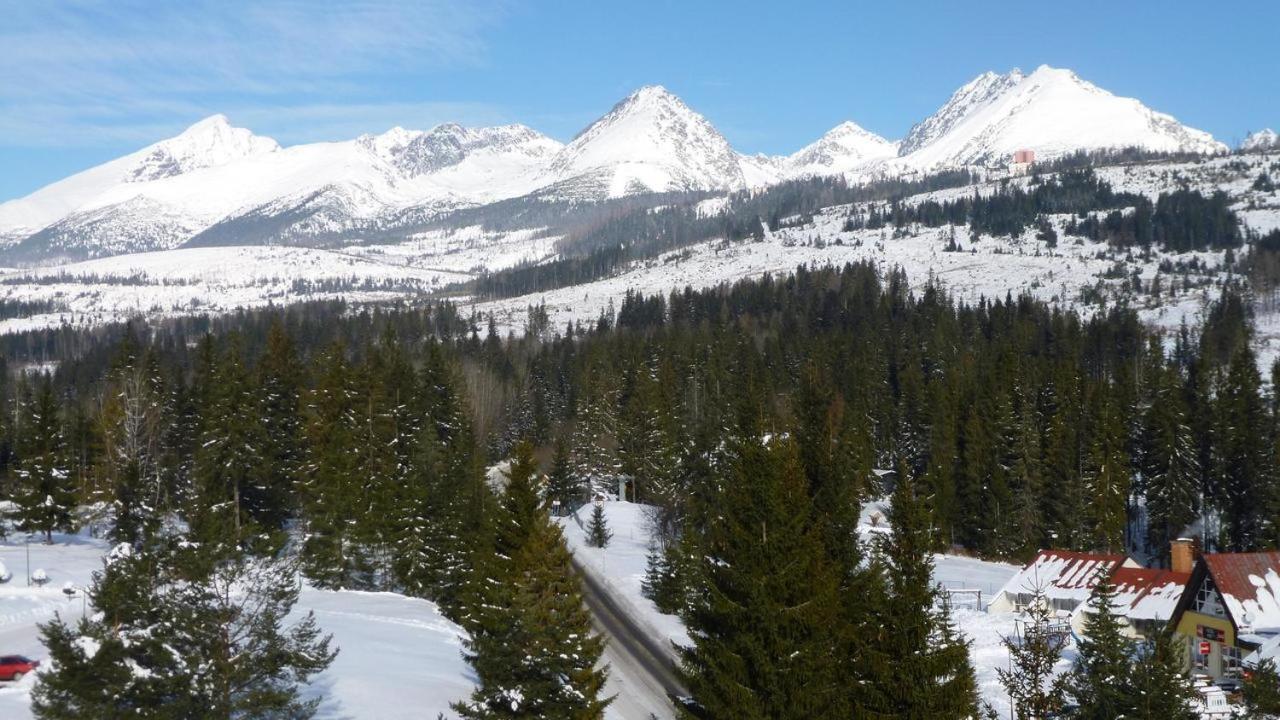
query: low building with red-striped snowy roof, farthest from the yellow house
987 550 1139 609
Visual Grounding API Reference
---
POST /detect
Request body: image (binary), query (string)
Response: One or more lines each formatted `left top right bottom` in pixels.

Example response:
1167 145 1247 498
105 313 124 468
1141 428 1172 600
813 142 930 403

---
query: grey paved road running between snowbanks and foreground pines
575 562 687 720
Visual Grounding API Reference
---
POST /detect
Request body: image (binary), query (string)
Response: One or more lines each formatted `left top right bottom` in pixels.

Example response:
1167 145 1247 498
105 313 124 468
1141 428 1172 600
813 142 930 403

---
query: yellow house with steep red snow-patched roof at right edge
1170 552 1280 680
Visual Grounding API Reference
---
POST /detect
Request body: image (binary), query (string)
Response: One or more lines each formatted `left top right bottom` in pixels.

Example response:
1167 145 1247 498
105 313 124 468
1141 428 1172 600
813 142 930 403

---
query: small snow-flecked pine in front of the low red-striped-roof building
996 588 1068 720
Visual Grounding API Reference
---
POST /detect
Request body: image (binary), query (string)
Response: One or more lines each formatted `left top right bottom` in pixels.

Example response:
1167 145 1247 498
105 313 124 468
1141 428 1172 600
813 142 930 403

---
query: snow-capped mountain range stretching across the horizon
0 67 1239 264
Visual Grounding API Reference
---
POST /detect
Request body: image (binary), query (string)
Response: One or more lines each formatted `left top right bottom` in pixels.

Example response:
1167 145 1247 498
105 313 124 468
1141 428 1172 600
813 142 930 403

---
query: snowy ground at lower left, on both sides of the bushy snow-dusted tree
0 534 475 720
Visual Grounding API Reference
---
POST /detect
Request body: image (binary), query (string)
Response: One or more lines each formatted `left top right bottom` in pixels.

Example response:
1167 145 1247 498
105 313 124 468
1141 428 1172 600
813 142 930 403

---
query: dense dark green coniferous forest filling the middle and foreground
0 260 1280 719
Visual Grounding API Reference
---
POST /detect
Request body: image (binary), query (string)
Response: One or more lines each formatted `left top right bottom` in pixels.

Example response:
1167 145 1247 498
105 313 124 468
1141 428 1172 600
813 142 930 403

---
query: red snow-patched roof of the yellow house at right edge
1204 552 1280 634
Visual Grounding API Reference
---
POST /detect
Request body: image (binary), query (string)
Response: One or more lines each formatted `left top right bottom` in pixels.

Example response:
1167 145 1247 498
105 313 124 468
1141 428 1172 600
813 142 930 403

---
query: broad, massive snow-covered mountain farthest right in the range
899 65 1226 168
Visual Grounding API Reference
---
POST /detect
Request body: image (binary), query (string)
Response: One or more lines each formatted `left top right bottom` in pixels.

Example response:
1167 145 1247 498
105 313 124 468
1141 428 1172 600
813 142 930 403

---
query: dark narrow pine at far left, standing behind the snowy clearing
13 377 76 543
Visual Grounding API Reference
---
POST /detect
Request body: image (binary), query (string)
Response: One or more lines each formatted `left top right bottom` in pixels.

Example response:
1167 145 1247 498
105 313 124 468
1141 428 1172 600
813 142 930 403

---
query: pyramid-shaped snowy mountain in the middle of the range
543 86 746 197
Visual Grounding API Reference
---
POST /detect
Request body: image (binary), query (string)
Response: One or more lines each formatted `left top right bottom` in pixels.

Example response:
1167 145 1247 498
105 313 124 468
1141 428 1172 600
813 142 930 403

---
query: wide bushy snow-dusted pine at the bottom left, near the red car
32 538 335 720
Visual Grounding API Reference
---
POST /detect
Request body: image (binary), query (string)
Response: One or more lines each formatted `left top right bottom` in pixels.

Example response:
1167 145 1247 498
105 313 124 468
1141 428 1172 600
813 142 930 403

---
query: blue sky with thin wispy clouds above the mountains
0 0 1280 200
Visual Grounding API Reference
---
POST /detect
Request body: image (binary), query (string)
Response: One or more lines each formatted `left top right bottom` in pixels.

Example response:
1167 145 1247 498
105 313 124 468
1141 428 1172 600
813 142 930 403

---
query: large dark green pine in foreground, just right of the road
681 436 845 720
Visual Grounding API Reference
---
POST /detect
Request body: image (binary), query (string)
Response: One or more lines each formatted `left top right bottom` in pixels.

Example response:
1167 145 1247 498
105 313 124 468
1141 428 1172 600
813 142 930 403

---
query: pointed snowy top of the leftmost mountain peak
124 113 280 182
